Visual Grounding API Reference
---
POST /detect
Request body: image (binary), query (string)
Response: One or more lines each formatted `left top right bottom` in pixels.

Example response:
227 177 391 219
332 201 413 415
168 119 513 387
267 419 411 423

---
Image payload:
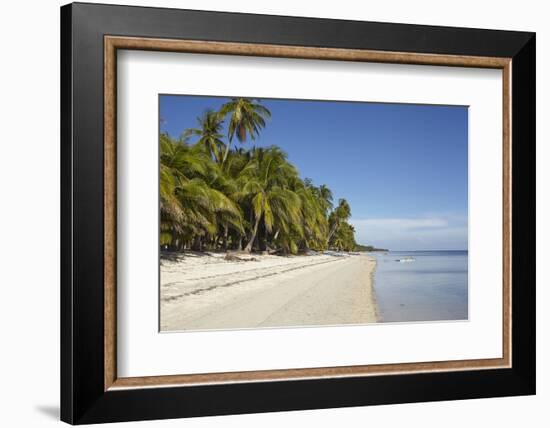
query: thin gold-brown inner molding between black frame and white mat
104 36 512 391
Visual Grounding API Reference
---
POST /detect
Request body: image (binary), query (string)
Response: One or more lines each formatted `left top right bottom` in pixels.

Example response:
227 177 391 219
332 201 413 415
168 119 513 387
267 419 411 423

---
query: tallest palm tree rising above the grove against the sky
219 98 271 162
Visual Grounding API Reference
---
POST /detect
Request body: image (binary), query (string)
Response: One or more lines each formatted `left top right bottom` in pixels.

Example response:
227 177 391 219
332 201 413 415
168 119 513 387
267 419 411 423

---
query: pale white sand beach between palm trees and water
160 254 378 331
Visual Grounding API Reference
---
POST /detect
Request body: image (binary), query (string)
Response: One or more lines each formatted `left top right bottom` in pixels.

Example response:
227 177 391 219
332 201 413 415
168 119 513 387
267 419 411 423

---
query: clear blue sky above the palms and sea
160 95 468 250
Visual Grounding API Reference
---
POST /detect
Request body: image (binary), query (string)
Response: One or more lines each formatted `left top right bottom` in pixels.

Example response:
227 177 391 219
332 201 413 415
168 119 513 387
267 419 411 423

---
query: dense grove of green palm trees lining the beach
160 98 357 254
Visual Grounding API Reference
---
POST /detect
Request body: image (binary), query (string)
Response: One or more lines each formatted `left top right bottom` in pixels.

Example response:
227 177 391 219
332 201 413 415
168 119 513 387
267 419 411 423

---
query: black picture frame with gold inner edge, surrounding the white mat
61 3 536 424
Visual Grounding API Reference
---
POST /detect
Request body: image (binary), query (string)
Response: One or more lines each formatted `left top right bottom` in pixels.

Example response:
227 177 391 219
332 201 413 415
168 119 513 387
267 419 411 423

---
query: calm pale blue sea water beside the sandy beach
371 251 468 322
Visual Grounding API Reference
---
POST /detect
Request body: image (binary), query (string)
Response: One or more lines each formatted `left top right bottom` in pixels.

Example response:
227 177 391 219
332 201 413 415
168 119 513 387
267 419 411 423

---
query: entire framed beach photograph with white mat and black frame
61 3 535 424
